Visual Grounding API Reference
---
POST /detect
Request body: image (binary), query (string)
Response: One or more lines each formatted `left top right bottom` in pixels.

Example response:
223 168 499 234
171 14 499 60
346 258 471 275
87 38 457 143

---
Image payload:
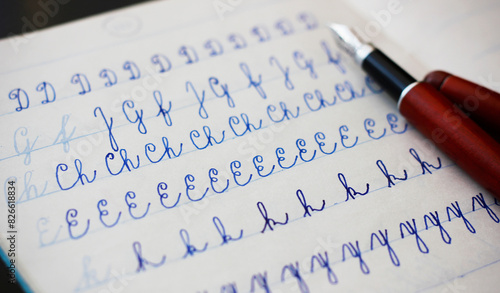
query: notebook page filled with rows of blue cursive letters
0 1 500 292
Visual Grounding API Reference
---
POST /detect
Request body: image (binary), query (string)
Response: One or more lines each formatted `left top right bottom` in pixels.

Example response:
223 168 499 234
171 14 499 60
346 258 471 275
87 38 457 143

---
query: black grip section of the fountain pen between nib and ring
361 49 416 101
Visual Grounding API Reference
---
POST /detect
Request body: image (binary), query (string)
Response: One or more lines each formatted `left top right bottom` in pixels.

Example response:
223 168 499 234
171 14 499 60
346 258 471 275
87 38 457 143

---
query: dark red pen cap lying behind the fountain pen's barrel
424 71 500 138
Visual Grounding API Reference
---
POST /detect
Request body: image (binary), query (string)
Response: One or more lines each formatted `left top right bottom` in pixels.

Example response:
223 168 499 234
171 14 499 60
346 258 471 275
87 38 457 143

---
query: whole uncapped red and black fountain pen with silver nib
330 24 500 199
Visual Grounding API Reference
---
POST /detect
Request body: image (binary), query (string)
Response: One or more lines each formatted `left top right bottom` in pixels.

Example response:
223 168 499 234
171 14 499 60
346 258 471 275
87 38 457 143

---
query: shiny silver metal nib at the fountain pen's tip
329 23 375 64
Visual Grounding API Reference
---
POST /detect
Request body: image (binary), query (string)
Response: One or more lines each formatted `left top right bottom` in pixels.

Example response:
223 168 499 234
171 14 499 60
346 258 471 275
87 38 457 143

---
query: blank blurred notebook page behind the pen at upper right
349 0 500 84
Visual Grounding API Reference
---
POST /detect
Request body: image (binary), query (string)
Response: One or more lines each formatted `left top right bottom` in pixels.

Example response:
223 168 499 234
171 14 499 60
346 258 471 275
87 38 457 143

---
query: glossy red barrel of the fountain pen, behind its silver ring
399 83 500 199
